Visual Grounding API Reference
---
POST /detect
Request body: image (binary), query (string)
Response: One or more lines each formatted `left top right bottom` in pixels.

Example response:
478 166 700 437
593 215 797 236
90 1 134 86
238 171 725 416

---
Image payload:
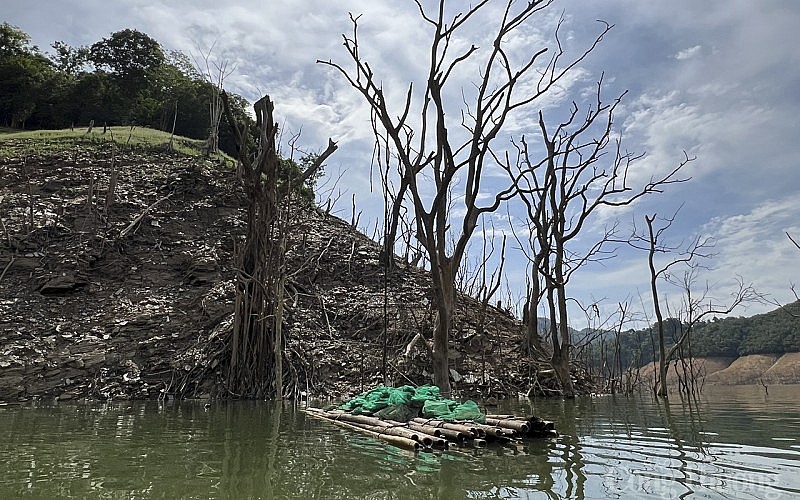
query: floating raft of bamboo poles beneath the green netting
304 408 558 451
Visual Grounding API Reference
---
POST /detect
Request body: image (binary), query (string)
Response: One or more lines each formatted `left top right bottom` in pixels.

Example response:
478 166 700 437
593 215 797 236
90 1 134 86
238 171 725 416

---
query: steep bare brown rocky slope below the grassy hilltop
0 141 568 401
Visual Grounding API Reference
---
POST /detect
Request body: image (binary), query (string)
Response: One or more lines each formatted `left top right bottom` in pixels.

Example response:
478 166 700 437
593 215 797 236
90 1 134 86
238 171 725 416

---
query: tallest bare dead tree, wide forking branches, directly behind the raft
317 0 605 394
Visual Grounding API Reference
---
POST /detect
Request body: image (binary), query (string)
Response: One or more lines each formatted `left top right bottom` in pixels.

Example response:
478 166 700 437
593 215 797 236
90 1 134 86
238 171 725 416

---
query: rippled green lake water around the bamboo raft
0 386 800 500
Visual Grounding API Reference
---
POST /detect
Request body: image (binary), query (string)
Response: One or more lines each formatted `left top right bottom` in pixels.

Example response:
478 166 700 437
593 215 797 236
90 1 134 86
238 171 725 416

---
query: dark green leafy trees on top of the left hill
0 23 250 155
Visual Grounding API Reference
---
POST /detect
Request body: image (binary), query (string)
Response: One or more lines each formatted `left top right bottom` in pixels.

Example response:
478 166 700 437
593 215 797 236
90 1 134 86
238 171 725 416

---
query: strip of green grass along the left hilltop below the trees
0 126 233 161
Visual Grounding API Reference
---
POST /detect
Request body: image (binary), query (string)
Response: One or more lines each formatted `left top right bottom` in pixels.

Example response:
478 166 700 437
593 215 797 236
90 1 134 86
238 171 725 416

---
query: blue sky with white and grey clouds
2 0 800 329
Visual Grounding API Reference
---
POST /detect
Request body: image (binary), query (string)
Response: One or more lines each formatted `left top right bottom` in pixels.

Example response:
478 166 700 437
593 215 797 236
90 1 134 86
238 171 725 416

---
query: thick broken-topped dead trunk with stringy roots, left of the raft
221 92 337 398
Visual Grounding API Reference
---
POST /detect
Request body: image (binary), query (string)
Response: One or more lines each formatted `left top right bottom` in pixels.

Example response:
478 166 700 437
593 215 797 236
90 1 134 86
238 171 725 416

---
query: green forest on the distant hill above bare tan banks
592 301 800 367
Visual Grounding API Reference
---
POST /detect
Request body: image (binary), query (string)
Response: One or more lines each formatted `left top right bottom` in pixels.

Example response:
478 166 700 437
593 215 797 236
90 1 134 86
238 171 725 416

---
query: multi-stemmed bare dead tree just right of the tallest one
505 78 691 397
